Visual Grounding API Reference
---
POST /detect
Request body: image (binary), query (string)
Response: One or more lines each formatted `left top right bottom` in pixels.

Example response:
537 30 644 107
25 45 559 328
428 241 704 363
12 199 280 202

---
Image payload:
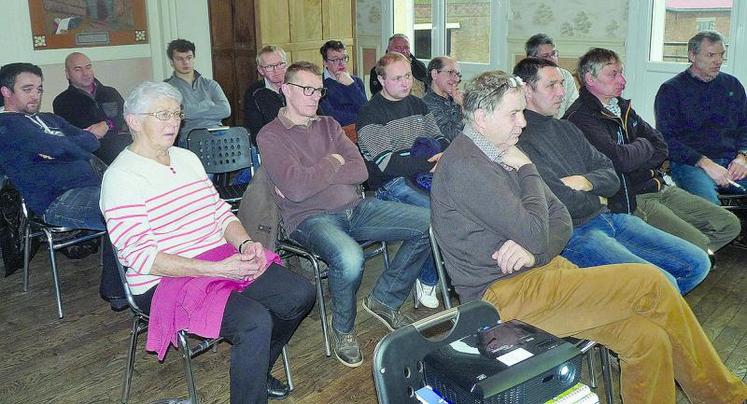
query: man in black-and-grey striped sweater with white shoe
356 52 449 308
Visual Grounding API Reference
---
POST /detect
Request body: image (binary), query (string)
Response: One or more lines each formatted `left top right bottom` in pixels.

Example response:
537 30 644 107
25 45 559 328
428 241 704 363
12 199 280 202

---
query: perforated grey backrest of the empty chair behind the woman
187 126 253 174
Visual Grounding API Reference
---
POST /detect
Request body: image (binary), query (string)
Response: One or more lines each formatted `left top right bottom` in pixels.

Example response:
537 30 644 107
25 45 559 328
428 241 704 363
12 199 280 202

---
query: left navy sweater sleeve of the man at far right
654 83 703 165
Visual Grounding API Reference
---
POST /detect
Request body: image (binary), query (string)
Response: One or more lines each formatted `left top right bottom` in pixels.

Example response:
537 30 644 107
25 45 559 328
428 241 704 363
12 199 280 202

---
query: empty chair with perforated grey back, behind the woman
187 126 258 205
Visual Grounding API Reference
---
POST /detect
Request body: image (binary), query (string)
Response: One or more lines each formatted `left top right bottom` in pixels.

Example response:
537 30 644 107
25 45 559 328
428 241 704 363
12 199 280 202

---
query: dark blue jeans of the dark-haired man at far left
43 187 126 300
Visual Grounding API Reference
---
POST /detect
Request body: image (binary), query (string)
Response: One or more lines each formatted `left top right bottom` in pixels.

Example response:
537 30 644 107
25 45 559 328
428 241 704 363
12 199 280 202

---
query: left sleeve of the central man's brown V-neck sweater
257 120 343 202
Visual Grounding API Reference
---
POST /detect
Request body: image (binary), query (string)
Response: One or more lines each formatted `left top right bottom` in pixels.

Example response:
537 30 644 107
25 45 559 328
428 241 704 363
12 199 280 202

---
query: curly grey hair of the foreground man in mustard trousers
463 70 524 122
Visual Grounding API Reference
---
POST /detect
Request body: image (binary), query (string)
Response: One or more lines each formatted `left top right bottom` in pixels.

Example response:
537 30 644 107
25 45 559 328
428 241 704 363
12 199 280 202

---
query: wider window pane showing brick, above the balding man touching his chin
446 0 492 63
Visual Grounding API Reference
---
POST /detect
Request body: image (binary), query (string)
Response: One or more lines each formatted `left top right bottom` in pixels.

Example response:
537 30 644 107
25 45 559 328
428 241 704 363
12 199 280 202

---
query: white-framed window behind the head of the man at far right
650 0 733 63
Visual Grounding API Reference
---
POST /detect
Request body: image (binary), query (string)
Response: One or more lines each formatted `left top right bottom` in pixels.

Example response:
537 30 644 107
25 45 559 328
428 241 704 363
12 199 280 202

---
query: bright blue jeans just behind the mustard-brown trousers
561 213 711 295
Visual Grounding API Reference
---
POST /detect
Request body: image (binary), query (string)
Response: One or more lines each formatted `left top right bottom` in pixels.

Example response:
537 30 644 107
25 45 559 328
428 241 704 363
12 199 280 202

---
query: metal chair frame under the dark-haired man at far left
21 198 106 318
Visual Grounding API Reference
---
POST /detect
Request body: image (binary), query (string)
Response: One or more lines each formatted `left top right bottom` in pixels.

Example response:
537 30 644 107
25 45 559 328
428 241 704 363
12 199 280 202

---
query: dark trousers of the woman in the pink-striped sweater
135 264 316 403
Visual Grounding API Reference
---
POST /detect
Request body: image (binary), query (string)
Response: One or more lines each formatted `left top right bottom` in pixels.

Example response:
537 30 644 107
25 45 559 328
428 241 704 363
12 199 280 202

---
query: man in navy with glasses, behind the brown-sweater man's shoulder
319 41 367 126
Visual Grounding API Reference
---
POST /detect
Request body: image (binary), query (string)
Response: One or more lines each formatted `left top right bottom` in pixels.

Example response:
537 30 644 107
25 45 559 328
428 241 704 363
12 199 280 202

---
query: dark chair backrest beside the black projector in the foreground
373 300 500 404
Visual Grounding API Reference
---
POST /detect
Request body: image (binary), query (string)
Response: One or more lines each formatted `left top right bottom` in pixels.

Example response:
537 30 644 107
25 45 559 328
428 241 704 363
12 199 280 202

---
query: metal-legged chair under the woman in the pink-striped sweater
115 251 293 404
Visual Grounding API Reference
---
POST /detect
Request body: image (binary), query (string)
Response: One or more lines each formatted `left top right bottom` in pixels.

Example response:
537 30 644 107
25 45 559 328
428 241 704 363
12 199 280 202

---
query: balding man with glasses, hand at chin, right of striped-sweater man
423 56 464 141
